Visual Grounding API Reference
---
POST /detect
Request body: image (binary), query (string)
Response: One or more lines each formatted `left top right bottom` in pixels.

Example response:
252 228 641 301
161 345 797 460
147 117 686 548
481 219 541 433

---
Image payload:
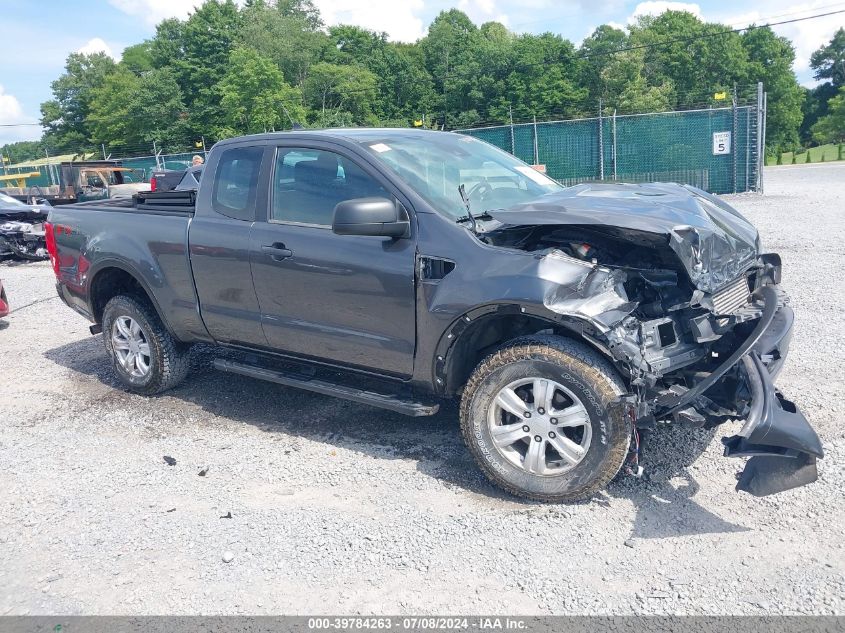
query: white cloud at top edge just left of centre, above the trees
314 0 425 42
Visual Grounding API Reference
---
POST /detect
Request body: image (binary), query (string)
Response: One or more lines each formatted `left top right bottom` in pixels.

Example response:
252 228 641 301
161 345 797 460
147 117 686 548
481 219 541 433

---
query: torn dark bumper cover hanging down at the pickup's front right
722 296 824 497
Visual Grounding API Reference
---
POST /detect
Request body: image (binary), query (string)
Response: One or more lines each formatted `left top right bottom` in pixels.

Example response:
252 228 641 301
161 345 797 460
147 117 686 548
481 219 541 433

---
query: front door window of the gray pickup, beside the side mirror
270 147 391 226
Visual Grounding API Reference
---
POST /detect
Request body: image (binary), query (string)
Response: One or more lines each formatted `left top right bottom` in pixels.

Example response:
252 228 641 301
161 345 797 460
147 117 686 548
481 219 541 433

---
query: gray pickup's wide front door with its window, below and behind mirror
251 146 416 376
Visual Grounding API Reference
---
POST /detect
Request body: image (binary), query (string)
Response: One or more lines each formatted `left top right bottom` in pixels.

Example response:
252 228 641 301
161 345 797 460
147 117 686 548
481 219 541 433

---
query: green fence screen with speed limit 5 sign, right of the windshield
456 105 764 193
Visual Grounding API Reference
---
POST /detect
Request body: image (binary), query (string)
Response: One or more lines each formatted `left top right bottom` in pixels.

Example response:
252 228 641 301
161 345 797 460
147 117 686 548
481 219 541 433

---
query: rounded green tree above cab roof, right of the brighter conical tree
304 62 376 127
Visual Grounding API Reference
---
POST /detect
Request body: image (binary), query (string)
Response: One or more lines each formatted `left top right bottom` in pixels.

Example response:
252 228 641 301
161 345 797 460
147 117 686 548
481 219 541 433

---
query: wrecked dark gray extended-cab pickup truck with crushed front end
47 129 822 502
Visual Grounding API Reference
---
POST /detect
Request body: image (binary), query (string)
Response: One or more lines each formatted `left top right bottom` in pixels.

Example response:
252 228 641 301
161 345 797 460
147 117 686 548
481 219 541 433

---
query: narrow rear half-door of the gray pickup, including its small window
188 146 268 347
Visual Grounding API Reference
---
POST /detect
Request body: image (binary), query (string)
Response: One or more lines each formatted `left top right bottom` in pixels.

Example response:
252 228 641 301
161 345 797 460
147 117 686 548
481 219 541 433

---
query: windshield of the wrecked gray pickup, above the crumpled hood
356 130 562 220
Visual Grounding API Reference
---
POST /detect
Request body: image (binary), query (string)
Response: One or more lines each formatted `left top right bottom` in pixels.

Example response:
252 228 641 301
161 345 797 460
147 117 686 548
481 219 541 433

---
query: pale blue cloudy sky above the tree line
0 0 845 145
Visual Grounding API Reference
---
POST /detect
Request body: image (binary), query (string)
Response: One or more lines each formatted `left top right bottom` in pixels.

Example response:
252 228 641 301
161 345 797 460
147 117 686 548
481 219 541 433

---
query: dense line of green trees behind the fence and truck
3 0 845 160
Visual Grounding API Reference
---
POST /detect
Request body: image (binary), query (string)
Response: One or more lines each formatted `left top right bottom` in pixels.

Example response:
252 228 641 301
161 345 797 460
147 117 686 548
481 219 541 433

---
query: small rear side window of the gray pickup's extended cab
211 147 264 221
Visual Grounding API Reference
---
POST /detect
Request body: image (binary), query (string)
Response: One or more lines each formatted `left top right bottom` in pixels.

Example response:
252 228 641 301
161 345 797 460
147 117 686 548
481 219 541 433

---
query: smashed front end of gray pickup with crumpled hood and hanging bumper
482 185 823 496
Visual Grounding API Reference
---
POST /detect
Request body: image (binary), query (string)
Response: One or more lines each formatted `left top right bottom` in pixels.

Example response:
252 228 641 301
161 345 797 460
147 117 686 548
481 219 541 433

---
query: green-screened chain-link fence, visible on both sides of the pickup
0 84 766 193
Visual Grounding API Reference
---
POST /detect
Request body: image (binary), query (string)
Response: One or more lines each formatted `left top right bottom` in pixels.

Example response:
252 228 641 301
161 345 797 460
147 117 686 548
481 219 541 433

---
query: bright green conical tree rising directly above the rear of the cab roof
218 48 306 137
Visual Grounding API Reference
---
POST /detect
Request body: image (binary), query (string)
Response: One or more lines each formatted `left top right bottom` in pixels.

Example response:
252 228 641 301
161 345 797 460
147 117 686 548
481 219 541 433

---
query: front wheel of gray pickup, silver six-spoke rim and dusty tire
460 335 631 503
